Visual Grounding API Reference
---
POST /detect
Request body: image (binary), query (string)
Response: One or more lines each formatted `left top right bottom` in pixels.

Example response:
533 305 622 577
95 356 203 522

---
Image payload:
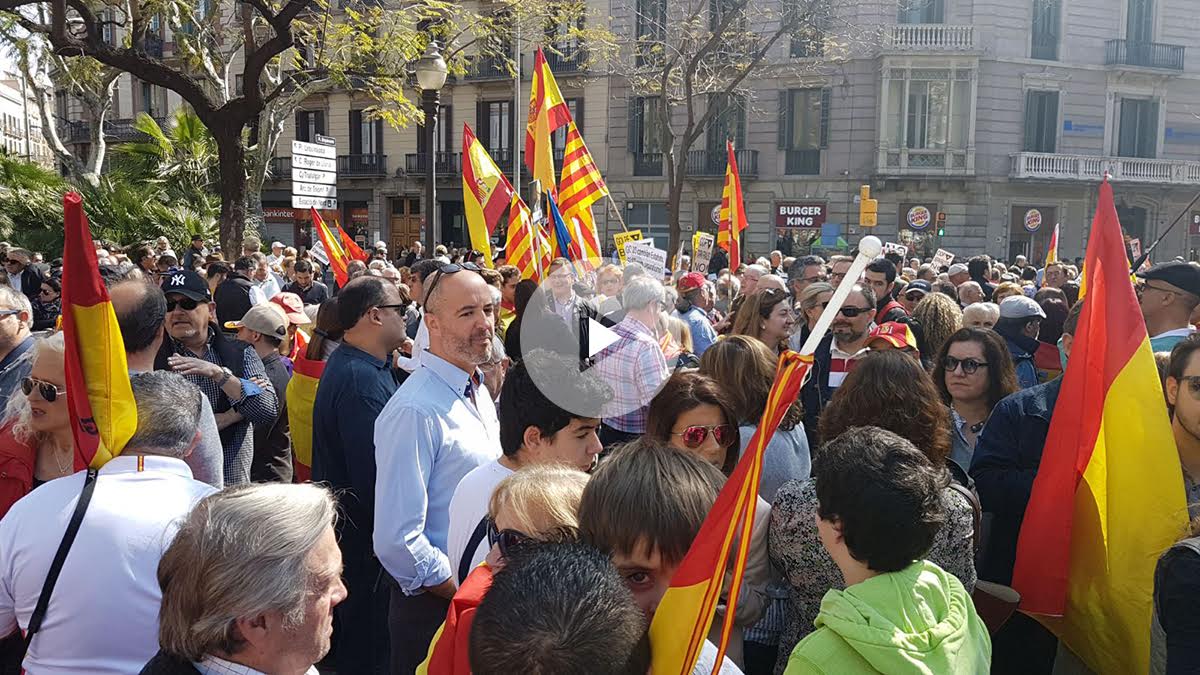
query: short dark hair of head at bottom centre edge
469 543 650 675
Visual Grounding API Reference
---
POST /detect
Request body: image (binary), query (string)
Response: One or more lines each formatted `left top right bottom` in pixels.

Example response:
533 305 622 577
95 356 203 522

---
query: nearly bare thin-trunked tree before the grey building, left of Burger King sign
614 0 850 251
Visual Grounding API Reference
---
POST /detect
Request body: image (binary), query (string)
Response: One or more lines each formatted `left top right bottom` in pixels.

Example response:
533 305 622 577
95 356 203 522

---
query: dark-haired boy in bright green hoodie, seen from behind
785 426 991 675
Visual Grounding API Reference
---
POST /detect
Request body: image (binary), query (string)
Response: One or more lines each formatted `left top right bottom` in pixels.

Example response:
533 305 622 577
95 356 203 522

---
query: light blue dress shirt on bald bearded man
374 351 500 596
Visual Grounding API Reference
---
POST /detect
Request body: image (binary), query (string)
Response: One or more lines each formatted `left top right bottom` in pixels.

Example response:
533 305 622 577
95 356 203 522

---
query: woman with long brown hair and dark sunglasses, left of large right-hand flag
934 328 1020 473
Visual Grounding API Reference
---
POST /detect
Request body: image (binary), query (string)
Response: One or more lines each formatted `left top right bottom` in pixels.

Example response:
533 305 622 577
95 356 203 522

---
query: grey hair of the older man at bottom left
158 483 337 661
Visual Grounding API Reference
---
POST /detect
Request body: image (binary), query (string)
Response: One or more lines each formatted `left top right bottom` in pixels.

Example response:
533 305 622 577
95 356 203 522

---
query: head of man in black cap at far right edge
1138 261 1200 352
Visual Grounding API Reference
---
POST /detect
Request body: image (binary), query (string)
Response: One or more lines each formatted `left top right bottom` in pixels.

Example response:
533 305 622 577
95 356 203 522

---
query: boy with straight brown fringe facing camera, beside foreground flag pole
580 440 742 675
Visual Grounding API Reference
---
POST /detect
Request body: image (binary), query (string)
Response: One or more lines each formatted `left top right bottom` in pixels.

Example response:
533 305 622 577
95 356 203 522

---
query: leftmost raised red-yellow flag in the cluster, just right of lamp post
462 124 514 267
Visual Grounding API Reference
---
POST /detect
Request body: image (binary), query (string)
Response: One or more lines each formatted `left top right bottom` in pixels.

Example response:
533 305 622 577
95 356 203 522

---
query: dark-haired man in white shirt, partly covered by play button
448 350 610 584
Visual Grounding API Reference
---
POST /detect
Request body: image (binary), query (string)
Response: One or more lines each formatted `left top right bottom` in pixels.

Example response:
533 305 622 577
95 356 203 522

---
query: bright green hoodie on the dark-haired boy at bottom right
785 561 991 675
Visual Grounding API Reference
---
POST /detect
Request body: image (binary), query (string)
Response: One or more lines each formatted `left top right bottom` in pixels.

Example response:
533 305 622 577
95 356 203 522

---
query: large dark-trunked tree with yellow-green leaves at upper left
0 0 604 250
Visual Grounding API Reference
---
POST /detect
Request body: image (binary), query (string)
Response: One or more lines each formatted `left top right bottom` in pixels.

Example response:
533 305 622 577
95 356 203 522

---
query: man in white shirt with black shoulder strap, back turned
0 371 215 675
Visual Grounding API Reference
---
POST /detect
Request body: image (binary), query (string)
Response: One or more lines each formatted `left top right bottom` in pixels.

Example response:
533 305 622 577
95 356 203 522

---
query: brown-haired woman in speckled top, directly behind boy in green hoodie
768 351 976 659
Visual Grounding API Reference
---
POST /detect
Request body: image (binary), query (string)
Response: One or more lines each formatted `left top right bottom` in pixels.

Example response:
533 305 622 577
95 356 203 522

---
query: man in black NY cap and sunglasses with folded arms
155 270 278 486
